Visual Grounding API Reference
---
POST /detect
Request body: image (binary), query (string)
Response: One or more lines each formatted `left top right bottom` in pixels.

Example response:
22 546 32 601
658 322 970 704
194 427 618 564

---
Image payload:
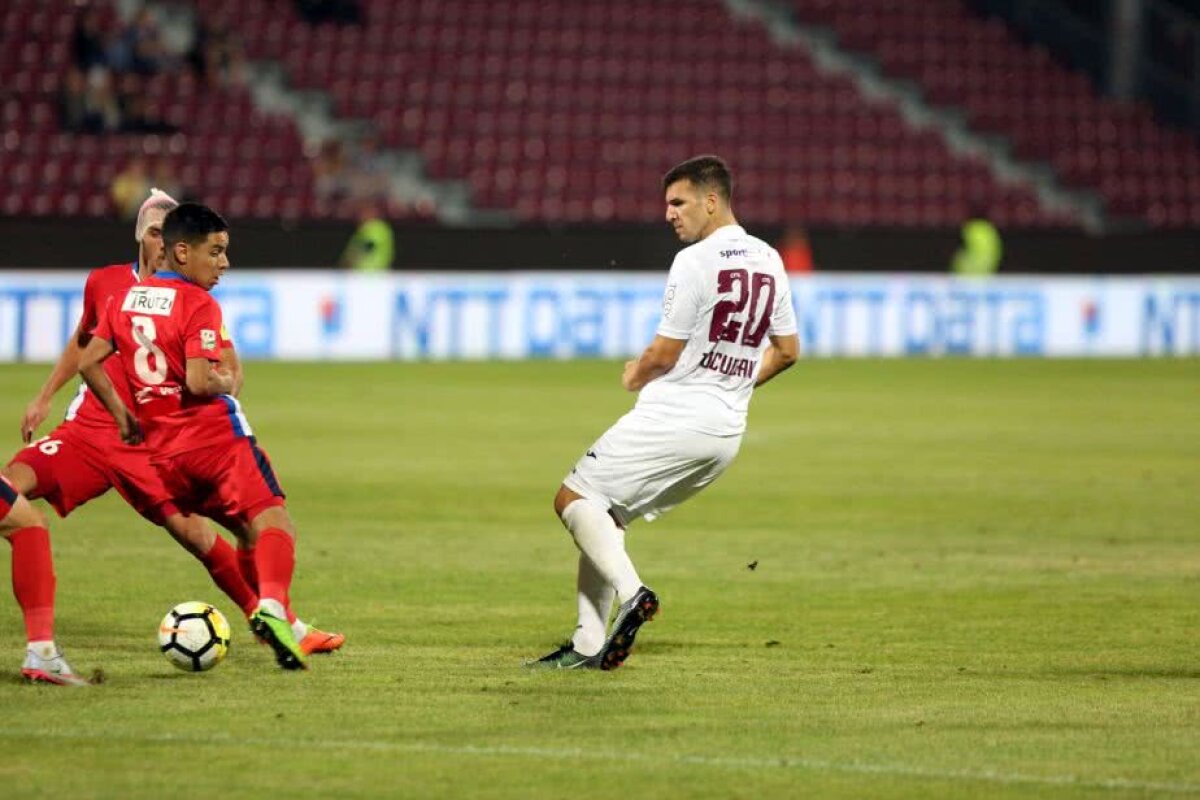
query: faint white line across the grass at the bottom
0 728 1200 794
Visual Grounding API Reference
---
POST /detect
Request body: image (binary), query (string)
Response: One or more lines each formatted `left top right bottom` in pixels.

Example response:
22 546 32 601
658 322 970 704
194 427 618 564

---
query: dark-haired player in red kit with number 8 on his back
79 203 306 669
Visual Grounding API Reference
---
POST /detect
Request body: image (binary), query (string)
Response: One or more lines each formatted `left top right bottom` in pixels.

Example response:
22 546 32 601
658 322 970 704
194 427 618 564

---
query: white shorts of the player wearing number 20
563 411 742 525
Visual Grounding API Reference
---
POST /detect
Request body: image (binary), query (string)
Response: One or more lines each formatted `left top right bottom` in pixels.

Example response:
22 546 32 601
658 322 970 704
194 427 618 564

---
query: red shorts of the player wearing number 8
157 438 284 528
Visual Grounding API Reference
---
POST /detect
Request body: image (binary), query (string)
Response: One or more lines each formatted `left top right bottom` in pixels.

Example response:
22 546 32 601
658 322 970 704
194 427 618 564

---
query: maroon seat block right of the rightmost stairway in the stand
792 0 1200 228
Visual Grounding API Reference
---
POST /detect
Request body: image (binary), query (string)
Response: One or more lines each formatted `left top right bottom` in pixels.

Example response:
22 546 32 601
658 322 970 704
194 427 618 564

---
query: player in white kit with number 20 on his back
529 156 799 669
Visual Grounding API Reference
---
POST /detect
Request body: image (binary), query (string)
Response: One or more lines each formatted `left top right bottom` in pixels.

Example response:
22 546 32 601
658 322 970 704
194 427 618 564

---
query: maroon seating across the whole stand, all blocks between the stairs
0 0 1200 228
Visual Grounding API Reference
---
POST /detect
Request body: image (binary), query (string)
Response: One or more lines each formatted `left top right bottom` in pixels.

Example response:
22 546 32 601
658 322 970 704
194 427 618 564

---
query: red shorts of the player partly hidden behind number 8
8 422 178 525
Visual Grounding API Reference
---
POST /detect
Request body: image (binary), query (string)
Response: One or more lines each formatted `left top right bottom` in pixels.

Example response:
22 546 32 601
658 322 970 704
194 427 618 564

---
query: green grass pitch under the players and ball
0 360 1200 799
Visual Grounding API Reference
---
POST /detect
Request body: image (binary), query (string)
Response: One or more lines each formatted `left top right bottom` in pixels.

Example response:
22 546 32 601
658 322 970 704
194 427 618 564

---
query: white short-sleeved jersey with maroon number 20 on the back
634 225 796 437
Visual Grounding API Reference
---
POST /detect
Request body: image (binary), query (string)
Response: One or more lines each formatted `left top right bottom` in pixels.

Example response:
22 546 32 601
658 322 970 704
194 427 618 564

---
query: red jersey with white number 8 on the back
95 272 253 461
